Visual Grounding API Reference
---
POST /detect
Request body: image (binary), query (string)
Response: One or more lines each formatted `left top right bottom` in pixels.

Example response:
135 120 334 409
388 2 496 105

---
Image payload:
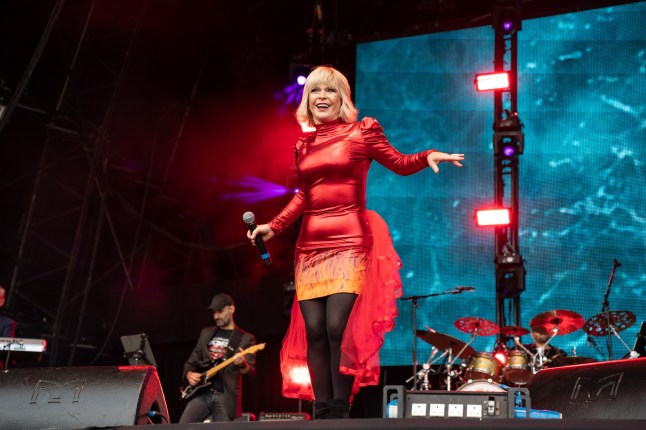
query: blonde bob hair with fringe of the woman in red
296 66 359 127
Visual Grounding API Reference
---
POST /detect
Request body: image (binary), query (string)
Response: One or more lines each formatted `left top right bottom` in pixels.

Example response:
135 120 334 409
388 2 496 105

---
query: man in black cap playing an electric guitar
179 293 256 423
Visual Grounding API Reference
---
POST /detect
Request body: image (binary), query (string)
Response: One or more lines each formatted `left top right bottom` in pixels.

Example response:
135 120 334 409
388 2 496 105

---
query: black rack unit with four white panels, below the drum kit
383 385 531 419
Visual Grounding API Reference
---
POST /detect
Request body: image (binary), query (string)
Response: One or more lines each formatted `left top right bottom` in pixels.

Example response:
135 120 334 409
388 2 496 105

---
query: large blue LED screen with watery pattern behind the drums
355 2 646 365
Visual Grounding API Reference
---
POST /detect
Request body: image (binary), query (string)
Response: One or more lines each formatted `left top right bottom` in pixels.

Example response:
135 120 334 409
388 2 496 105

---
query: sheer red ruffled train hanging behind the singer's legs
280 211 402 400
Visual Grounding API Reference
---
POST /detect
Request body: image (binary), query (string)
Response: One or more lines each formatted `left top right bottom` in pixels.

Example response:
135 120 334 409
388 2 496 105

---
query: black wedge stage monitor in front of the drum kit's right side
528 358 646 420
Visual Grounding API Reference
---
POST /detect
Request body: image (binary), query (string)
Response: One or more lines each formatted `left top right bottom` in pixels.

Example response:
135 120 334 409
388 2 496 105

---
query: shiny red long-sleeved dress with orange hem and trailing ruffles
269 117 432 400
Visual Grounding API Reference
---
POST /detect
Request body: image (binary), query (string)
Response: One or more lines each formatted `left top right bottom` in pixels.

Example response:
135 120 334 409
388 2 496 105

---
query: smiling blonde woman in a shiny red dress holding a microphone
247 66 464 419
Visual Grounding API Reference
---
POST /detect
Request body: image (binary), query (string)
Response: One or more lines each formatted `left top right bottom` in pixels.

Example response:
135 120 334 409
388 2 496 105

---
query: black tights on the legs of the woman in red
299 293 357 403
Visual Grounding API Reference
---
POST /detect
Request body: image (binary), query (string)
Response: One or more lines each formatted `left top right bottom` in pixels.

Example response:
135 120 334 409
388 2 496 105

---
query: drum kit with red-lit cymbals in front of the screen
407 310 635 392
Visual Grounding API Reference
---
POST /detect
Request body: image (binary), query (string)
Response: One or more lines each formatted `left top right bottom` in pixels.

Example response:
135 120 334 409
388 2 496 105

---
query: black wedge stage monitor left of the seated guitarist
0 366 168 430
